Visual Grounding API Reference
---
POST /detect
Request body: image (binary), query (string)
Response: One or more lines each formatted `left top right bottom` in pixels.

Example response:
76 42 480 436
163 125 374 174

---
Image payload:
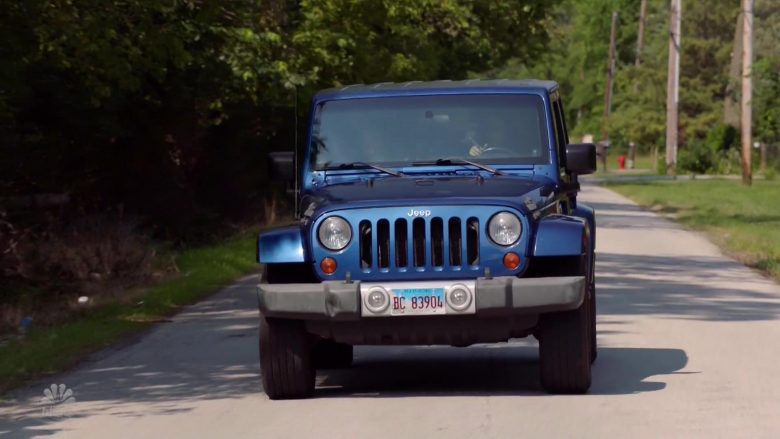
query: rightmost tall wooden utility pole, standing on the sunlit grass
740 0 753 186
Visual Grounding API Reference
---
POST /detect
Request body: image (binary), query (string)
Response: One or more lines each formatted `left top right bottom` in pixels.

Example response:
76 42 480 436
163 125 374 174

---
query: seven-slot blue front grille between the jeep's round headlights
358 217 479 271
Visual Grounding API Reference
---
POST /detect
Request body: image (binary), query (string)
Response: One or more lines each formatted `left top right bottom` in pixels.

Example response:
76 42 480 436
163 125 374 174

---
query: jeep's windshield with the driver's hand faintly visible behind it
310 95 549 169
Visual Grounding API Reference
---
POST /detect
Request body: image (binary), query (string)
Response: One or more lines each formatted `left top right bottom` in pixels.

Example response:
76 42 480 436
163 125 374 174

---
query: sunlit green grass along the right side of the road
607 180 780 280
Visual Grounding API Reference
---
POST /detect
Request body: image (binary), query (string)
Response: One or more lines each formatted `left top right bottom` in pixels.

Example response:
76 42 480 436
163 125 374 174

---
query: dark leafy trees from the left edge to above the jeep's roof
0 0 555 236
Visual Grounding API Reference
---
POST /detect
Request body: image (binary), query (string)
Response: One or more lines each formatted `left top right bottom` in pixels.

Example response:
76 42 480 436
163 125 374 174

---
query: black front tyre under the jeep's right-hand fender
539 295 592 393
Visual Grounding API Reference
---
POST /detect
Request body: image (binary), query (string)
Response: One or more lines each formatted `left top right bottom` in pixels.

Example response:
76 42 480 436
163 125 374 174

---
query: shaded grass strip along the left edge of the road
0 234 257 395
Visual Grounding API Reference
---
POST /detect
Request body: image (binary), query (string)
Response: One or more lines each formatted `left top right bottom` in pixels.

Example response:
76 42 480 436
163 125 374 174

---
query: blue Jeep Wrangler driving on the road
257 80 596 399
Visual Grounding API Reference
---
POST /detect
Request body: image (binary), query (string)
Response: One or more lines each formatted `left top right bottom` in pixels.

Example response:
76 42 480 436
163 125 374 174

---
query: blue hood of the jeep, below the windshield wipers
302 175 555 216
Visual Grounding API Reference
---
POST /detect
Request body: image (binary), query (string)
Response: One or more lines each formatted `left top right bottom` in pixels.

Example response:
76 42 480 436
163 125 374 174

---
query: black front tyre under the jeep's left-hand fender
260 316 315 399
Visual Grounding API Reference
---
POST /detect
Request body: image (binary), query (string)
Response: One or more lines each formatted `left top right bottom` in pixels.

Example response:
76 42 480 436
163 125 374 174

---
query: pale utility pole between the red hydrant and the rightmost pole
666 0 682 175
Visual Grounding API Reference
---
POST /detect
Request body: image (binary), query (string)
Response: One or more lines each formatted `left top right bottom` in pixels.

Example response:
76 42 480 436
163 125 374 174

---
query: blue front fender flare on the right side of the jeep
533 215 588 257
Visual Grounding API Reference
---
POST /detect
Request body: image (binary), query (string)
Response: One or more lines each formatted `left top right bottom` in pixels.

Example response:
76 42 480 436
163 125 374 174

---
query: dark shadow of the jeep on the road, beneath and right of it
316 343 688 398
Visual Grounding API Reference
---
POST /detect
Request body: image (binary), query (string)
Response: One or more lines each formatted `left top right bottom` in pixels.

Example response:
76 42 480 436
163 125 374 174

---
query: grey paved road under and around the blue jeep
0 186 780 438
